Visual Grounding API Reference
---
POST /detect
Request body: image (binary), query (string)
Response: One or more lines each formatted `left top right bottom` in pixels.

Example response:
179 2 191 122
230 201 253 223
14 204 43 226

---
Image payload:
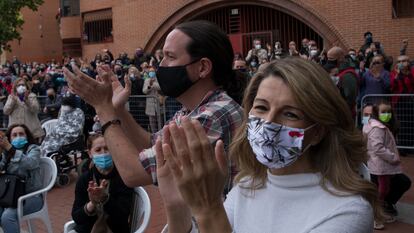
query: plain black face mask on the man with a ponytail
157 59 200 98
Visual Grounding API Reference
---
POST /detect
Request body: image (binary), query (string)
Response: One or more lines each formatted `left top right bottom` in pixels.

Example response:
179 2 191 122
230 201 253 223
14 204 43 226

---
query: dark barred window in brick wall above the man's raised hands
83 9 113 43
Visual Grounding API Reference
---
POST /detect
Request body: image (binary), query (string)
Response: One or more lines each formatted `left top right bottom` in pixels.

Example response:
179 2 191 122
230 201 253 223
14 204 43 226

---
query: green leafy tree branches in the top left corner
0 0 43 54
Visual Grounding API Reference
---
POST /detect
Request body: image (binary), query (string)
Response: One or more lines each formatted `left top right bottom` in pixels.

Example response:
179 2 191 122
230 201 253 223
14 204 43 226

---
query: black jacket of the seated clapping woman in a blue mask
72 167 134 233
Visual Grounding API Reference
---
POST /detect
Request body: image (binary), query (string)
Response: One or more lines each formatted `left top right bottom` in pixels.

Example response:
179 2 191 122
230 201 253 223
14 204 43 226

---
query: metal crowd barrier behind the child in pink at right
361 94 414 149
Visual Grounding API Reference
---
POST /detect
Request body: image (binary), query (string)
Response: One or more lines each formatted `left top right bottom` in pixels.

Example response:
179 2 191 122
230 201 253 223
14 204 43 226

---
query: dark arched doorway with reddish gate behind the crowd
194 5 323 56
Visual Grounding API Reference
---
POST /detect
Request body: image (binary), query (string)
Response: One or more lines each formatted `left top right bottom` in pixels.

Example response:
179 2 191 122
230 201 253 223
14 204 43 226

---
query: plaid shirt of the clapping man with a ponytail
139 89 243 191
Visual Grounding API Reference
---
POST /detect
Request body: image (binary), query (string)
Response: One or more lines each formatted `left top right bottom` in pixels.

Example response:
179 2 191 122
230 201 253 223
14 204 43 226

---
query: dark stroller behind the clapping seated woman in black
47 135 89 187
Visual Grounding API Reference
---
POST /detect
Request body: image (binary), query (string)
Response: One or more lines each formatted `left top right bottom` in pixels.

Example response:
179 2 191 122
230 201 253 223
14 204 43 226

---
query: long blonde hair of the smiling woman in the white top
230 58 381 217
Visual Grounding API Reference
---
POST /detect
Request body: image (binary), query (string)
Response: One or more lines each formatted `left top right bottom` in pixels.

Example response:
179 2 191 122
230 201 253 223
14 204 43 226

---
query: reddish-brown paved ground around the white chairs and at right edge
12 156 414 233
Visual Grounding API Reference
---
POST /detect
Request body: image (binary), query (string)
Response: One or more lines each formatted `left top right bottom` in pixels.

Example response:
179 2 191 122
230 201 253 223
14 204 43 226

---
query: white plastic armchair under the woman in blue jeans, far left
17 157 57 233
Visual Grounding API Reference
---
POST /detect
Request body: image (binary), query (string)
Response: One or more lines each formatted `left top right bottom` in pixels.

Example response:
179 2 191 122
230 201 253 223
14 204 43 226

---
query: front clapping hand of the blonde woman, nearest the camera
158 117 227 220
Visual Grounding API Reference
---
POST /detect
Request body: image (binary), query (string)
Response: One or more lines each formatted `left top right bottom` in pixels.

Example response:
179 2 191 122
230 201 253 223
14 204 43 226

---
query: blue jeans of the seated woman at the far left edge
0 196 43 233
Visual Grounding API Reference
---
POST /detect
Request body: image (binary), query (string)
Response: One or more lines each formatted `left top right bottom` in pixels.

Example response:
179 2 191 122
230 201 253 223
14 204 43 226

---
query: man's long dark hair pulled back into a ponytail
175 20 246 104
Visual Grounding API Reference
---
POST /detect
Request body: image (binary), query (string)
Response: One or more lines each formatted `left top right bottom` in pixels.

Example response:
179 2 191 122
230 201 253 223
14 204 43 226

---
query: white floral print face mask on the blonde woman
247 115 316 169
